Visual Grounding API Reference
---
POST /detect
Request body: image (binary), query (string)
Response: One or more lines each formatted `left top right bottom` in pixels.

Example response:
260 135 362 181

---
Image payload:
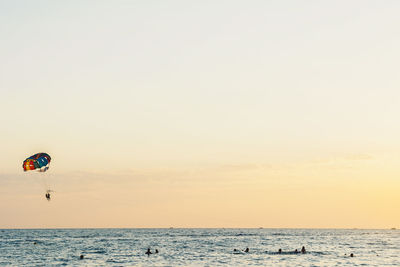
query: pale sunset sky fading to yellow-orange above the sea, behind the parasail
0 0 400 228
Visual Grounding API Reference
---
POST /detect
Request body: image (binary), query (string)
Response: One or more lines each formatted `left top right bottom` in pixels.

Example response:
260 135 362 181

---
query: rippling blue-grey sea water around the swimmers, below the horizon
0 229 400 266
